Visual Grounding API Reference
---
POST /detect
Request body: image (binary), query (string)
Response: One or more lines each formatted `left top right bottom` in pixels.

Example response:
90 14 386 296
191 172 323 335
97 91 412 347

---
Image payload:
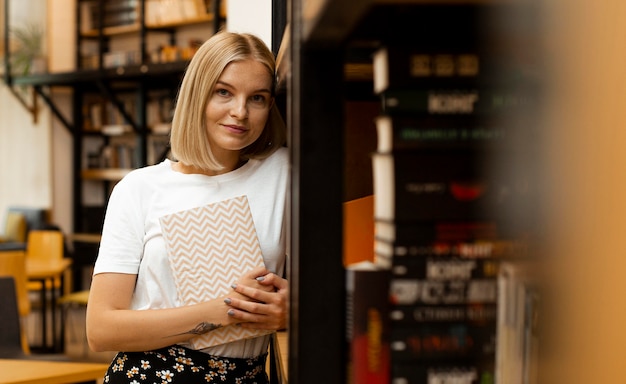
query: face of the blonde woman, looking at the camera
205 60 274 158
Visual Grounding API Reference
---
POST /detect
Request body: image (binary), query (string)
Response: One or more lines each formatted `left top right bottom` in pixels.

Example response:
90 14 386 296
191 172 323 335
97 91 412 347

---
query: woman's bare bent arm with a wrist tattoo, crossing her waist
87 269 267 352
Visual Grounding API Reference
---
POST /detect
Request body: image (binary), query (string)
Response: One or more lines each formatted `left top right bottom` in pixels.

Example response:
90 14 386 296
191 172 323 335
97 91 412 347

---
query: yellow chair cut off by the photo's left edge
0 250 31 355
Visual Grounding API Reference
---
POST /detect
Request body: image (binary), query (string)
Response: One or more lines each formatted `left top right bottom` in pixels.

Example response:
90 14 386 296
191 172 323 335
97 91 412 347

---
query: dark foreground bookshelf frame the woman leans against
286 0 532 384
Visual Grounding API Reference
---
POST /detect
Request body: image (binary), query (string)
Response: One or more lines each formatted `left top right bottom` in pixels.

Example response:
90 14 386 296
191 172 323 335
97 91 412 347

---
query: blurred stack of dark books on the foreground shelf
347 30 534 384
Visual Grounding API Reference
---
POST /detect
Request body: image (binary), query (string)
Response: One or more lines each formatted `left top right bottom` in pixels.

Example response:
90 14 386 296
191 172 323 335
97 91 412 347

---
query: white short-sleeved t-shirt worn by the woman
94 148 289 358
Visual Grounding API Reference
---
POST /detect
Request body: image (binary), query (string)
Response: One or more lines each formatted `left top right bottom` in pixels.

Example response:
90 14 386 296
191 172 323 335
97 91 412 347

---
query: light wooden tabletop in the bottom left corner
0 359 109 384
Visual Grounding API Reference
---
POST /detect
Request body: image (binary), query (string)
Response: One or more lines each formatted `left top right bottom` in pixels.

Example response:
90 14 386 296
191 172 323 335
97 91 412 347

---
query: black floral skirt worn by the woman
104 345 268 384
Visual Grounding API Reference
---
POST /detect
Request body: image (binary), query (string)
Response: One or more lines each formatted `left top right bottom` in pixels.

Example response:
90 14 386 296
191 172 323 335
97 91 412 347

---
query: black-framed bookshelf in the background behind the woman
4 0 225 288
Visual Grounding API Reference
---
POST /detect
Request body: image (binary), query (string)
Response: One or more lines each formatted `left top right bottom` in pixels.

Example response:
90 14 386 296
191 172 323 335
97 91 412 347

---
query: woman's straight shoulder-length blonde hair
170 31 286 171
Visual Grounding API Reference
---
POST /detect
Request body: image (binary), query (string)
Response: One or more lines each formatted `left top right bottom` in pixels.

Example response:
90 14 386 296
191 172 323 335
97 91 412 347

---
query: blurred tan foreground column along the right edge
536 0 626 384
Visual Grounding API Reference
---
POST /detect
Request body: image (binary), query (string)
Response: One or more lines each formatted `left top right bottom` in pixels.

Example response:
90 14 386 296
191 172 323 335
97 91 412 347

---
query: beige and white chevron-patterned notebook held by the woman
160 196 272 349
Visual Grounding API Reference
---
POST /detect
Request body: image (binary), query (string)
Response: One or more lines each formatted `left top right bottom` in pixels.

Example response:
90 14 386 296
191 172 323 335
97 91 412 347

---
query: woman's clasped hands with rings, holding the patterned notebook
224 268 289 330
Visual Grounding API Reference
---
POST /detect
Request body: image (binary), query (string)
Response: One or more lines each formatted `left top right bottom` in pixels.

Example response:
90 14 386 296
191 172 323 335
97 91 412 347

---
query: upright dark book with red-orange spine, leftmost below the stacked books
346 261 390 384
